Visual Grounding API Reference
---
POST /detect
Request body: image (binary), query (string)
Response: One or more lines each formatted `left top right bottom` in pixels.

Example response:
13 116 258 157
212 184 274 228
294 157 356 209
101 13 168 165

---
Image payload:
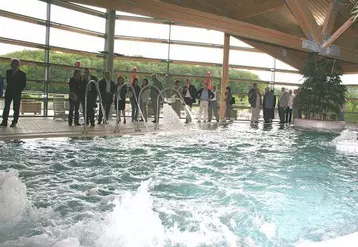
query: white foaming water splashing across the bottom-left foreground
0 172 241 247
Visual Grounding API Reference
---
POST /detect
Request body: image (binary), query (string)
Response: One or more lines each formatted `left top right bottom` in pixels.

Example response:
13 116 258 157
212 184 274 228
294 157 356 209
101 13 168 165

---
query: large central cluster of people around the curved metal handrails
68 69 238 126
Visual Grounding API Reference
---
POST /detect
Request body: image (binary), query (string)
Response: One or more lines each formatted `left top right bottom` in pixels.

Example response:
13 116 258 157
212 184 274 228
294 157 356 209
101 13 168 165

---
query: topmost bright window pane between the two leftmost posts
51 5 106 33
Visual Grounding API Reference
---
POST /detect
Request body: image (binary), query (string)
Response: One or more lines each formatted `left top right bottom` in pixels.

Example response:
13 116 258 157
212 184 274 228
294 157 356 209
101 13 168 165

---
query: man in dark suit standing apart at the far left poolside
0 59 26 127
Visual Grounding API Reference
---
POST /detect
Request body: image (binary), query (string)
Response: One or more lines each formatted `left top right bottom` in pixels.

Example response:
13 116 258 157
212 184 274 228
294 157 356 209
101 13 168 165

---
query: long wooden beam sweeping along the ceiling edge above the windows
69 0 305 50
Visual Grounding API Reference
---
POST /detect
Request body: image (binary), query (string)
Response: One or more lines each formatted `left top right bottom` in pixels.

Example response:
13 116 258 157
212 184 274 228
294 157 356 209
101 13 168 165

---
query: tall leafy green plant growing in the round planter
297 54 347 120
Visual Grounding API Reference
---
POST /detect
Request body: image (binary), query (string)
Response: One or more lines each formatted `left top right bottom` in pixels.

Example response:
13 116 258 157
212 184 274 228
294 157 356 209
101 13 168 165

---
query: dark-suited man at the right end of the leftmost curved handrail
98 71 116 124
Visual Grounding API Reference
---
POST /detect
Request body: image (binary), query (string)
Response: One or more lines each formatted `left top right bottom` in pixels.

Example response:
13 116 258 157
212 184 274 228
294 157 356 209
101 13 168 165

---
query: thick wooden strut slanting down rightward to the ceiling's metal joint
285 0 323 44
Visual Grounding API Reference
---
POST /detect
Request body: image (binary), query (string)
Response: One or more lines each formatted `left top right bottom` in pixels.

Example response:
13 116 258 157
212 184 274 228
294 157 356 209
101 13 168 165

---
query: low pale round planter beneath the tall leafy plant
294 118 346 131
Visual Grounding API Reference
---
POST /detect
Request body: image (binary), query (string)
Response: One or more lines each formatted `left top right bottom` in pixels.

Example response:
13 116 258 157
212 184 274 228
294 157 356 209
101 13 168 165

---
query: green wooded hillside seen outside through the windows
0 50 265 94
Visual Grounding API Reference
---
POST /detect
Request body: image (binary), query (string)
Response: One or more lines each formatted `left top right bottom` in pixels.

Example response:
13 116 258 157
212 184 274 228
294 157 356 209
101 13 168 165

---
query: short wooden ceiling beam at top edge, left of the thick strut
238 0 285 20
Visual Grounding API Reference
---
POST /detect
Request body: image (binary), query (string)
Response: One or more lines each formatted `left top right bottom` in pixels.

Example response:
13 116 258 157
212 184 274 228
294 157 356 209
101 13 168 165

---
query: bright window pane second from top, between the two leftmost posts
50 28 104 52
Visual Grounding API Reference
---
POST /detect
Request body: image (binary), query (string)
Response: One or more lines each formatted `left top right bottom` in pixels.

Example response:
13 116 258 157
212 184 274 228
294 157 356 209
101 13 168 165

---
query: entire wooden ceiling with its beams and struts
68 0 358 73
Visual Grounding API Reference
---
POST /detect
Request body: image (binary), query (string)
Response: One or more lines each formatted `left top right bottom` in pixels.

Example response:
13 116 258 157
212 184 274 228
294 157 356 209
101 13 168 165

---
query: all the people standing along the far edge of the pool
0 59 301 127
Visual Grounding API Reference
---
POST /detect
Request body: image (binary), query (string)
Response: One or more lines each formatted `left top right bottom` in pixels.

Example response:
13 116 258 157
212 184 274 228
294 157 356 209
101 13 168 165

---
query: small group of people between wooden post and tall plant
248 83 300 125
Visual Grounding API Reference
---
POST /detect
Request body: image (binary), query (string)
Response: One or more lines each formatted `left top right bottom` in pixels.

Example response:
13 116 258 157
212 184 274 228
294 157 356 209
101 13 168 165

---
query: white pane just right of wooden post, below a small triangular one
229 51 273 68
